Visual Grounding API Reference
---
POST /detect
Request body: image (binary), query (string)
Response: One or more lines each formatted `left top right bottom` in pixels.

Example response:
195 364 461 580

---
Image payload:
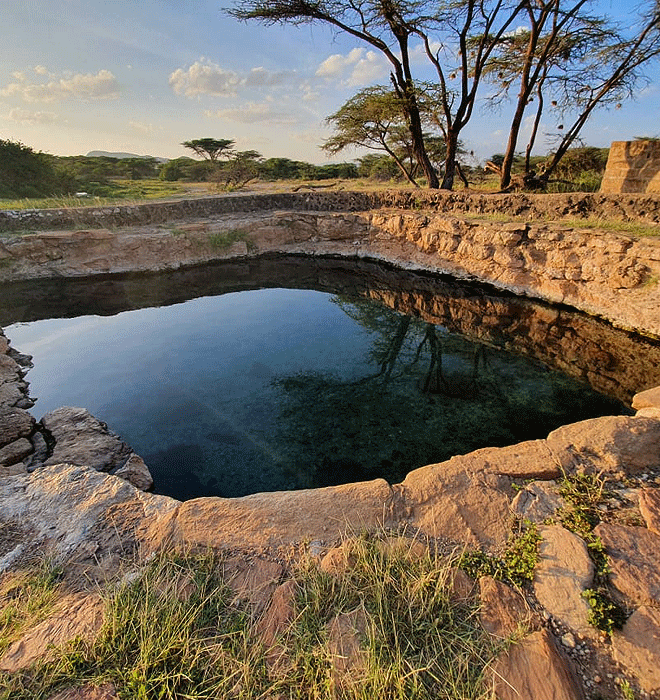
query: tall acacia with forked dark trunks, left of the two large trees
229 0 525 189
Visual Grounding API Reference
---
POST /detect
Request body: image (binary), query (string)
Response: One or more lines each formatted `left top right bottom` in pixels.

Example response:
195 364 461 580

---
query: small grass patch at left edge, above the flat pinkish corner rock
0 561 62 656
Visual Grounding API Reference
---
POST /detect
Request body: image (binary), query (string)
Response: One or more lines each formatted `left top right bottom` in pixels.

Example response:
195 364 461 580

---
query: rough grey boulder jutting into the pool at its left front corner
41 406 131 471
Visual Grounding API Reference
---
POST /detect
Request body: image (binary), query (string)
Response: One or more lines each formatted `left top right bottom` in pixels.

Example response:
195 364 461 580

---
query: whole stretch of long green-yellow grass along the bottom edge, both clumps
0 536 510 700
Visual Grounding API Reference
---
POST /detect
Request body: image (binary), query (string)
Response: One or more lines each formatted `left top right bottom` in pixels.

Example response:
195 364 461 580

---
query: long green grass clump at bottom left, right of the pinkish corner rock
0 556 258 700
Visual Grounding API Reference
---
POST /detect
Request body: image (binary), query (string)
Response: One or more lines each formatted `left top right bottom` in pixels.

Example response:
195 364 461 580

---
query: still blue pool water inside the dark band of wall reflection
5 260 623 499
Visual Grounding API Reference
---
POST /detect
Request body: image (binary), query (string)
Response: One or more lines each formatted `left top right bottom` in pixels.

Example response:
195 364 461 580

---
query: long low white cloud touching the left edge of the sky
0 68 120 102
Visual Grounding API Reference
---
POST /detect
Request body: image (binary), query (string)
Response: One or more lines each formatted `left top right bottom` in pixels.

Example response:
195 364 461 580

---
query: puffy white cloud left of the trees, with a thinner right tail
169 58 289 97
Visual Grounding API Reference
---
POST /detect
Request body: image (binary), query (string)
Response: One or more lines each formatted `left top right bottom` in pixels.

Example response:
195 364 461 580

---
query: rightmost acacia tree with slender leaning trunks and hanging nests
487 0 660 189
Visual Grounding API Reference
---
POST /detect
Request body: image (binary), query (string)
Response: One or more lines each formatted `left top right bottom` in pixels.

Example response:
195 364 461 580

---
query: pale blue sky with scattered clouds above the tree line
0 0 660 164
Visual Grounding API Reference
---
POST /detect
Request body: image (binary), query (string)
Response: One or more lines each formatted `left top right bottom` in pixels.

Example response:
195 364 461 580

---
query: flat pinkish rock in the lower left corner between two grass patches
0 594 103 673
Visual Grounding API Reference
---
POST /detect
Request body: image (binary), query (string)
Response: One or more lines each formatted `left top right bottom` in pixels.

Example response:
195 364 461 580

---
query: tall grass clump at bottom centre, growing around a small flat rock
284 537 501 700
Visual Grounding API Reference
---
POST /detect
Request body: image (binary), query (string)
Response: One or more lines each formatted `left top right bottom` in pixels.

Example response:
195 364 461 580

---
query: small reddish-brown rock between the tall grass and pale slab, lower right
479 576 532 639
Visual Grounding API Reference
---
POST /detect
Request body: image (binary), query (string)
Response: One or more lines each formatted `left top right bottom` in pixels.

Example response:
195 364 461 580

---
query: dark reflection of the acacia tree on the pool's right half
276 297 620 488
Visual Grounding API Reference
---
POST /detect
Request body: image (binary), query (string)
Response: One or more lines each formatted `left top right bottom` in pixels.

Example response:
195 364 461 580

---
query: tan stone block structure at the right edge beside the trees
600 140 660 194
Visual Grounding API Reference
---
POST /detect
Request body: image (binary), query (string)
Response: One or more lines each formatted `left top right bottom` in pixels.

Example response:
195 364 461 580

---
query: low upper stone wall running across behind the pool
0 190 660 232
